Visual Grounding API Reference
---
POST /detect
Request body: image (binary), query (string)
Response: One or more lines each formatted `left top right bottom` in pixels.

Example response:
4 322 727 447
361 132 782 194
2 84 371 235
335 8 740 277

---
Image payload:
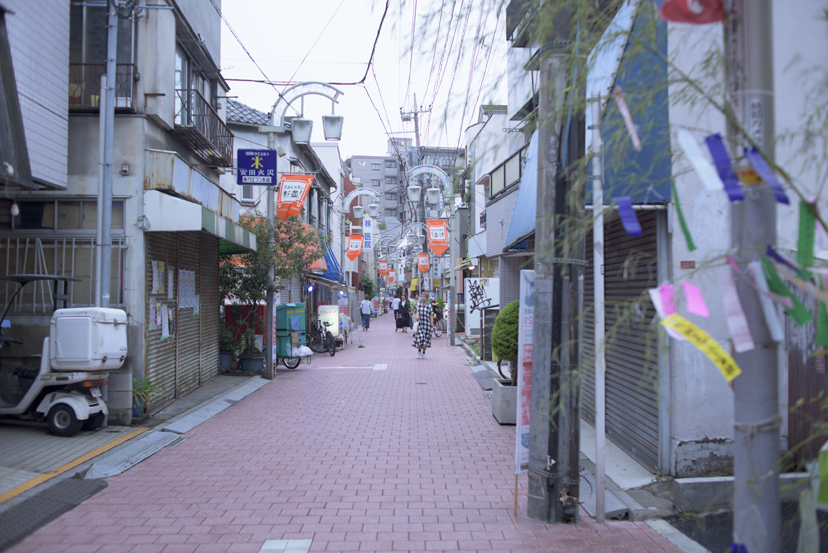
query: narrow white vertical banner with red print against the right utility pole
515 270 535 474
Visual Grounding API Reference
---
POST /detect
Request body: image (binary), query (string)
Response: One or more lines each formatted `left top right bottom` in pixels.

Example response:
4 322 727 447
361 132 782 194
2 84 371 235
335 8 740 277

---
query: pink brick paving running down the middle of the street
10 316 680 553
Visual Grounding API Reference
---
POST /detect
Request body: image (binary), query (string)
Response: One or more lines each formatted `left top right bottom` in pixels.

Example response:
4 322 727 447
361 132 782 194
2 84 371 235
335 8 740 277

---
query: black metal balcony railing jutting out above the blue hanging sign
173 89 233 167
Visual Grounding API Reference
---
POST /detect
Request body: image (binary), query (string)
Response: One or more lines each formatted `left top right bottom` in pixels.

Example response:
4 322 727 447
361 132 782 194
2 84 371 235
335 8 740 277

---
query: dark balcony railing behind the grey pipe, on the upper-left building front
69 63 135 111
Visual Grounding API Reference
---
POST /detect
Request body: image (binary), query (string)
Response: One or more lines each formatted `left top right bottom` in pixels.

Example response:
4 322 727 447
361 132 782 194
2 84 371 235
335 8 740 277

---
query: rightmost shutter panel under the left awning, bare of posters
197 232 219 384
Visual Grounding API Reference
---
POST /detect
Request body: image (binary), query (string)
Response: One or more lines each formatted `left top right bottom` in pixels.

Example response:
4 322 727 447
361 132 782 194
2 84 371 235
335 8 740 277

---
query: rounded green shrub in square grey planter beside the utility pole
492 301 520 424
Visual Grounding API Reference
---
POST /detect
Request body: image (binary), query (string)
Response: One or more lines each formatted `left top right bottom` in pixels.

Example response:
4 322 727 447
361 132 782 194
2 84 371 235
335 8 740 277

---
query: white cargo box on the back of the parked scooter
49 307 127 371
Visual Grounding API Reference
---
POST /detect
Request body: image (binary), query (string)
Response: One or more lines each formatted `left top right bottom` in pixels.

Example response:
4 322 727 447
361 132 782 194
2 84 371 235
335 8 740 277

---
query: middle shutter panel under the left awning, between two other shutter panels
174 232 200 397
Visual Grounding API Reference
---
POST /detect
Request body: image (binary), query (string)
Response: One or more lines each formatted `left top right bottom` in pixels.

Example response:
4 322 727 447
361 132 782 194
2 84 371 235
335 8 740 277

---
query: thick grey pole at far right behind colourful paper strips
725 0 782 553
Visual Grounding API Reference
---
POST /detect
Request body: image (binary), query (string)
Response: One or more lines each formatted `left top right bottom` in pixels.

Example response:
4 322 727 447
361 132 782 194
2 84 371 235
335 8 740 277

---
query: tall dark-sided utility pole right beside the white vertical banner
527 1 583 522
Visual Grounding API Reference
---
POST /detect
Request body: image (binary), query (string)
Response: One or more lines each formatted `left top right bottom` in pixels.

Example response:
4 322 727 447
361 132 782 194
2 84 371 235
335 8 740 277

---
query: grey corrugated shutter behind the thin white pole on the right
582 211 658 471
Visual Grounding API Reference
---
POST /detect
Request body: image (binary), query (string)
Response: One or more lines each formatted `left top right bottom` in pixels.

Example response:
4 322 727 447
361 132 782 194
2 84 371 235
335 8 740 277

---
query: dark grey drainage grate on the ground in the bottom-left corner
0 478 106 551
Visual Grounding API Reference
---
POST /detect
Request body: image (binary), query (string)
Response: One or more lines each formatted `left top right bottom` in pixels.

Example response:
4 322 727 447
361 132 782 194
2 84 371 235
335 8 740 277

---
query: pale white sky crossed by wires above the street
221 0 507 159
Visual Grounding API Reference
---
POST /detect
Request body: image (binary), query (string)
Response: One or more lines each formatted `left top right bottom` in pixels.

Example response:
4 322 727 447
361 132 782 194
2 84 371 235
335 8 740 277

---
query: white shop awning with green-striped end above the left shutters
144 190 256 255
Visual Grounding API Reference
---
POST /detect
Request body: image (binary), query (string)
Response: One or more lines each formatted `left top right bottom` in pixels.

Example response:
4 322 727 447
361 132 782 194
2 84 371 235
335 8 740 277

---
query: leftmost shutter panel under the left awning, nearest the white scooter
144 232 177 413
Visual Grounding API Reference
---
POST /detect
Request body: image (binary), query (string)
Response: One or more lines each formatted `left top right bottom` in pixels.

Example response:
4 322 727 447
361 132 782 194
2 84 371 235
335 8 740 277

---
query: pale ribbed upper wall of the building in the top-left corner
3 0 69 188
